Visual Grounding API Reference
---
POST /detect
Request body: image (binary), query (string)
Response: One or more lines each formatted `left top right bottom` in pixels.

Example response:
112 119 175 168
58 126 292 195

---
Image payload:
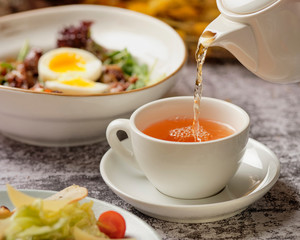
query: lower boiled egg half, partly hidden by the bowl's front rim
44 76 109 95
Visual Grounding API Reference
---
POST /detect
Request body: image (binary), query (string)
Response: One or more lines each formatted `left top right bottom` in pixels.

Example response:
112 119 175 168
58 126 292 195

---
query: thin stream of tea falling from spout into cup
193 31 215 142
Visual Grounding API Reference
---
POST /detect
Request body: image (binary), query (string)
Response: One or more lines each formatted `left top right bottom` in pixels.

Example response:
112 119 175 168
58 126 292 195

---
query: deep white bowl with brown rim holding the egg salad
0 5 187 146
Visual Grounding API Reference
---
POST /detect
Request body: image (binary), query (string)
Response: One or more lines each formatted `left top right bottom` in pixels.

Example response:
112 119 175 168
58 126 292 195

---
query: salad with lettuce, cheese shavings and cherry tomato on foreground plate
0 185 126 240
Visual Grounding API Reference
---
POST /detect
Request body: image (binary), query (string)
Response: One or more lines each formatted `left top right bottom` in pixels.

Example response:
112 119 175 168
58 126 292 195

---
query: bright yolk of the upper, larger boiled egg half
49 53 86 73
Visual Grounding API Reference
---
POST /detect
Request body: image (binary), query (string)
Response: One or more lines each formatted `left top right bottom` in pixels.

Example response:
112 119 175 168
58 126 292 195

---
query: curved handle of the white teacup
106 118 141 170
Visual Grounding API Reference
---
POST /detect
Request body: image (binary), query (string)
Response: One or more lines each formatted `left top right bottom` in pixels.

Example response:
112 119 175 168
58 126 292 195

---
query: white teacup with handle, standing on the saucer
106 97 250 199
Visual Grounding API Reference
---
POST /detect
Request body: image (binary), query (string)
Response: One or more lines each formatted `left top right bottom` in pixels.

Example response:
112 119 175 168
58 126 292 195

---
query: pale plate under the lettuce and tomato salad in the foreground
0 190 161 240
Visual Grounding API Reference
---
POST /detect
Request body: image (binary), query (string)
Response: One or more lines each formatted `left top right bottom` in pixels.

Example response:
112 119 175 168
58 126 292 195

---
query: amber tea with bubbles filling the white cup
143 118 234 142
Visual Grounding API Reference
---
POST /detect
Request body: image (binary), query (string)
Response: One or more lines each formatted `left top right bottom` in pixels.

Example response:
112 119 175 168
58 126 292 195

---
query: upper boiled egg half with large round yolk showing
38 48 102 82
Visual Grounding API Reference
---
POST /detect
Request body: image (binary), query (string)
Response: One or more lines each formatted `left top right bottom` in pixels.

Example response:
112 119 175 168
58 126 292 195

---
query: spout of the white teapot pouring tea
203 15 258 73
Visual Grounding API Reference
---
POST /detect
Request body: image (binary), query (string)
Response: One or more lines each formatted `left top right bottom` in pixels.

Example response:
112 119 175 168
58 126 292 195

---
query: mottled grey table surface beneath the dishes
0 58 300 240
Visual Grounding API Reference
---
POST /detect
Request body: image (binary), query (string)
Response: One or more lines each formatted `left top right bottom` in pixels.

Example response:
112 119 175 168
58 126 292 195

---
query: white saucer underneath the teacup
100 139 280 223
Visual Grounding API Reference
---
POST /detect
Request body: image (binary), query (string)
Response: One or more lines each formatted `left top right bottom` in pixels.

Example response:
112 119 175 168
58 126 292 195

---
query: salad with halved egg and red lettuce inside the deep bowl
0 21 153 95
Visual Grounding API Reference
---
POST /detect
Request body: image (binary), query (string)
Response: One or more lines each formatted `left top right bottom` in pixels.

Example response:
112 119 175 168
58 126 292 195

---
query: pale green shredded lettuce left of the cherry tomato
5 199 108 240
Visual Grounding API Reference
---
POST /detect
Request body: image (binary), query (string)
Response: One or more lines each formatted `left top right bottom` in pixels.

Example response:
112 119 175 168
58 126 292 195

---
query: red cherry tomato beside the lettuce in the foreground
97 211 126 238
